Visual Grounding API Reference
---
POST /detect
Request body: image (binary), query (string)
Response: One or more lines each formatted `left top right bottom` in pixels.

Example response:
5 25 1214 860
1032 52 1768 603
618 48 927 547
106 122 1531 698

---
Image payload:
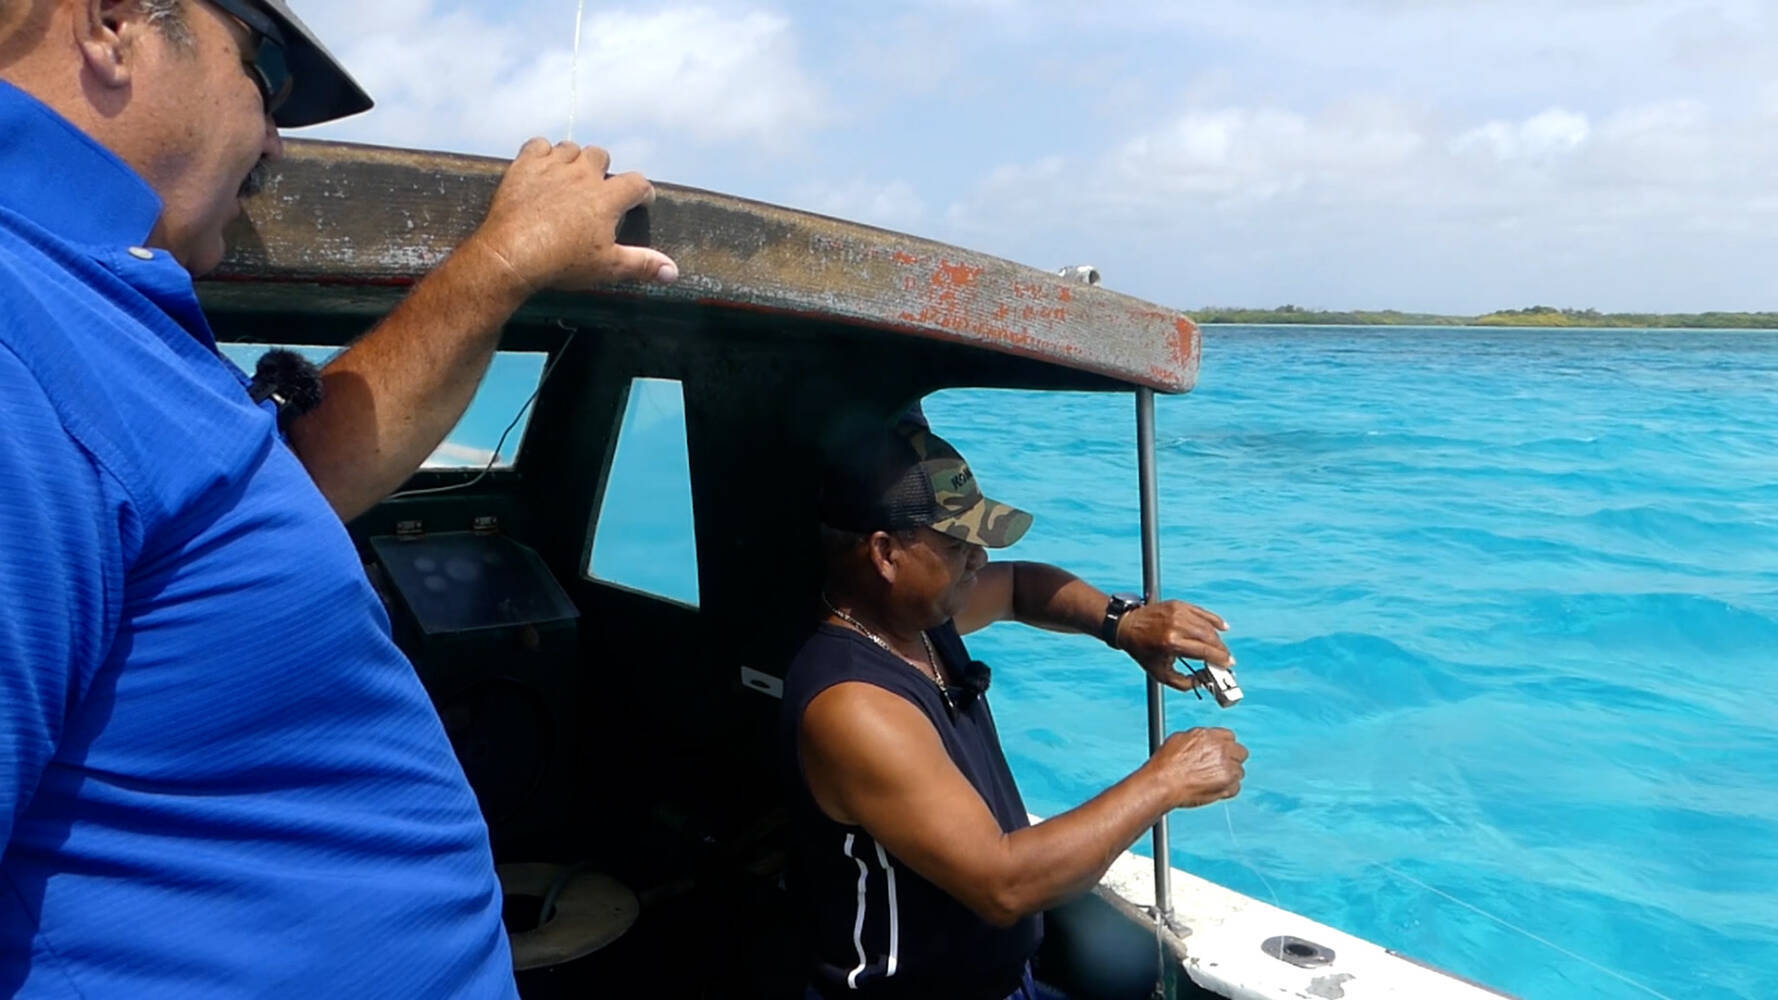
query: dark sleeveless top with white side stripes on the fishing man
781 623 1044 1000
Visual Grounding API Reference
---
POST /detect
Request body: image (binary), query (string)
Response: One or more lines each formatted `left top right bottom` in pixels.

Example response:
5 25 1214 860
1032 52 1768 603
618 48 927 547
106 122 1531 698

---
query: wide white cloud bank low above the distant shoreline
946 89 1778 311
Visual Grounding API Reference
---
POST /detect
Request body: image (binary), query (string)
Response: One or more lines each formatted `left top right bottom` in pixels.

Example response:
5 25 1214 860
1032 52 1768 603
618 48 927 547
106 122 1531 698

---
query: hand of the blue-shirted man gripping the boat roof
468 139 679 294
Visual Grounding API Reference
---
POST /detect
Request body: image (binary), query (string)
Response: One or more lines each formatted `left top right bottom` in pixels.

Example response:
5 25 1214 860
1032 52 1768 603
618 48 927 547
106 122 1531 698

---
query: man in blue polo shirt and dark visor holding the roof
0 0 677 998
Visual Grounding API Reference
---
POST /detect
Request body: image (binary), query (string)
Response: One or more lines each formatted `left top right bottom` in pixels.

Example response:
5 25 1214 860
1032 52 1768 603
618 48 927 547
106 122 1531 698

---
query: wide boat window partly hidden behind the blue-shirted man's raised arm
219 343 549 470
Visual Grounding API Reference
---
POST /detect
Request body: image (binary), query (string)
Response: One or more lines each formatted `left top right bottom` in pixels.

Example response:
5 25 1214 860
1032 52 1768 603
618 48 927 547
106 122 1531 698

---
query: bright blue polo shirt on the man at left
0 84 516 998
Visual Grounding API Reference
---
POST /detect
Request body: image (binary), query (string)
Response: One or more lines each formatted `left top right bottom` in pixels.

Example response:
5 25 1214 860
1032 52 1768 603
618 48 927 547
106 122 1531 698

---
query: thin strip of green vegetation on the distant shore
1189 306 1778 329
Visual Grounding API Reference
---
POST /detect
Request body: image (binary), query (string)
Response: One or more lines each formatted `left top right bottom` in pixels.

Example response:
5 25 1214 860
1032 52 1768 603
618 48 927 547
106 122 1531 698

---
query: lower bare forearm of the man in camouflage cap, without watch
989 769 1172 923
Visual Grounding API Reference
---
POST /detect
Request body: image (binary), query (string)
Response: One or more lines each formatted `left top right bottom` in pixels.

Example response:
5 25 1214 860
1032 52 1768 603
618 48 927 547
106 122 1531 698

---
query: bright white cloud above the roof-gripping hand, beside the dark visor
306 0 827 155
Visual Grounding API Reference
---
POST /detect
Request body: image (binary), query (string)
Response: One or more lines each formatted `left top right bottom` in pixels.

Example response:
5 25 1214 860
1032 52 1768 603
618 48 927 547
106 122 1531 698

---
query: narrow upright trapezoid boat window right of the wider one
587 379 697 607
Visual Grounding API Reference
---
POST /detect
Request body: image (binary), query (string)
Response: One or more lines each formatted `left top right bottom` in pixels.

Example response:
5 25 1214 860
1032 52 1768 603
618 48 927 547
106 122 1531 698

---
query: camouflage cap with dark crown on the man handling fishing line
820 422 1031 548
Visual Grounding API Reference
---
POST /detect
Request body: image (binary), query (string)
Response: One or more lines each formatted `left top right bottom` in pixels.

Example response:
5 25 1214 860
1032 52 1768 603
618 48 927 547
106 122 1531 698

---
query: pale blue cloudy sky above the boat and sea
292 0 1778 315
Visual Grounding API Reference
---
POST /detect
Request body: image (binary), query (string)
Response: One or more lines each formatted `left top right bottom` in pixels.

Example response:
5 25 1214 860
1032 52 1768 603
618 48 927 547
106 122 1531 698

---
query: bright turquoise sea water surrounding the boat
440 327 1778 1000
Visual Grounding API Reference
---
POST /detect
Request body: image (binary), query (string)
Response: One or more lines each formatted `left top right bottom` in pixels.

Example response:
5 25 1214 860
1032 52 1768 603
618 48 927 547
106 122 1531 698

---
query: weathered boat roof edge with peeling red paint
199 141 1200 391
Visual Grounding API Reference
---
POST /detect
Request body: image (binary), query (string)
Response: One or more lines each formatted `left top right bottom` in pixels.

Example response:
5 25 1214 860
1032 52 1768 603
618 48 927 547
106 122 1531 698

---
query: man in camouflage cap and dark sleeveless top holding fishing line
781 420 1246 1000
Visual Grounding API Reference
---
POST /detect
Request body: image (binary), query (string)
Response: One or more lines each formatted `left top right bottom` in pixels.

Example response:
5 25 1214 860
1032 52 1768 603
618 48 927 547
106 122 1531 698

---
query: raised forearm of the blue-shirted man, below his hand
290 237 528 520
